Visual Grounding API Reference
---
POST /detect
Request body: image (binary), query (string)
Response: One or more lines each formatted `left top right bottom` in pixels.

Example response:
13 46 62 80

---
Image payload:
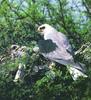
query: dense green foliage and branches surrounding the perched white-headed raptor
0 0 91 100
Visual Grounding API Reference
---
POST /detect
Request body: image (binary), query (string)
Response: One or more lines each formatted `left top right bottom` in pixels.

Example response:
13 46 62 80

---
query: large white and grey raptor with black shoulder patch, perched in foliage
38 24 87 80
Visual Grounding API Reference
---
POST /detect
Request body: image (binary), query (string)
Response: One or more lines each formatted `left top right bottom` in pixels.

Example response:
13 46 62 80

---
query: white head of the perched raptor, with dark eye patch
38 24 56 36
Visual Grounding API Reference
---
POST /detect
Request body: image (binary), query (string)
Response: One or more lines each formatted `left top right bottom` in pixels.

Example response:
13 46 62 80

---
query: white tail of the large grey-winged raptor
67 63 88 80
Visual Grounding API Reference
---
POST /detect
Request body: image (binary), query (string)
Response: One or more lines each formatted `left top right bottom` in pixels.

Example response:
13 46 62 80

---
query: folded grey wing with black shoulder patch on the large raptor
38 40 82 70
